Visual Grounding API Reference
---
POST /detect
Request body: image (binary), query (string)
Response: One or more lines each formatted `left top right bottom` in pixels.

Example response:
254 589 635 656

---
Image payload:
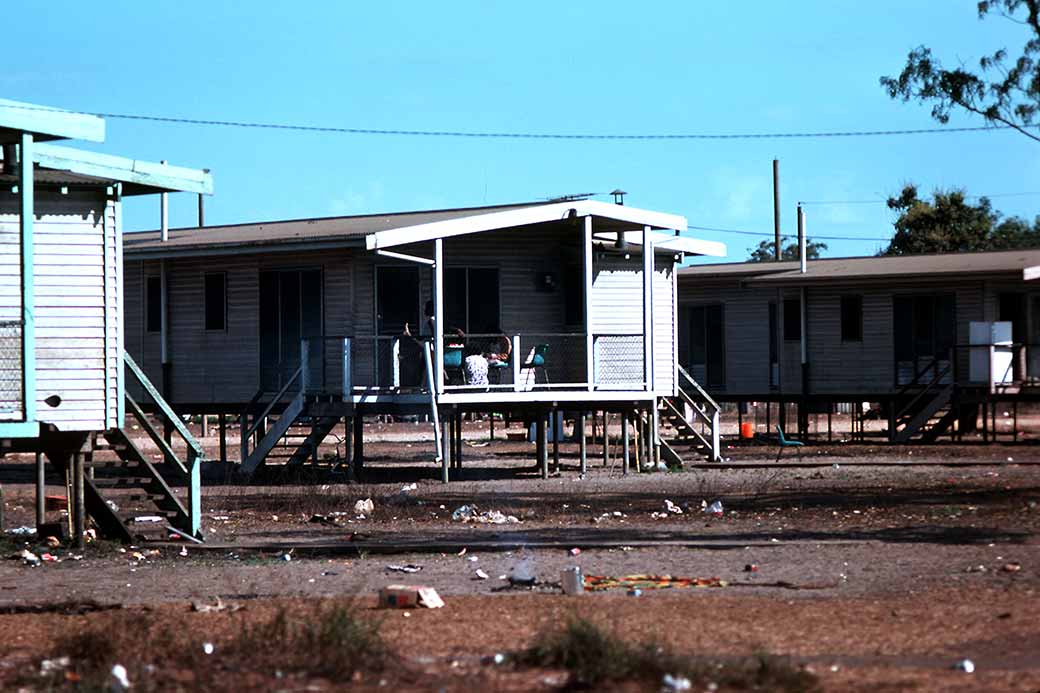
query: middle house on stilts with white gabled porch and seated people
124 199 725 481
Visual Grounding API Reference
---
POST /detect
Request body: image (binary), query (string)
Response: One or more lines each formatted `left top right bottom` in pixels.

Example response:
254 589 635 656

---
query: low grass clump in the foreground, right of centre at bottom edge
513 617 820 693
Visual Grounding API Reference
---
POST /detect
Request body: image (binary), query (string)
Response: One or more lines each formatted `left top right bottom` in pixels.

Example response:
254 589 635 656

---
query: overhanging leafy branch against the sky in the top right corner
881 0 1040 142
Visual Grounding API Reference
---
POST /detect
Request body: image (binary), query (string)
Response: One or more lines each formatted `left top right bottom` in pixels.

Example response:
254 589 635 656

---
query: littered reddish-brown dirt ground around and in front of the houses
0 425 1040 691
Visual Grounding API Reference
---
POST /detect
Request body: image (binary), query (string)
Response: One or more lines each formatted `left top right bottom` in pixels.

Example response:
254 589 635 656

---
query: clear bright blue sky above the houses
0 0 1040 260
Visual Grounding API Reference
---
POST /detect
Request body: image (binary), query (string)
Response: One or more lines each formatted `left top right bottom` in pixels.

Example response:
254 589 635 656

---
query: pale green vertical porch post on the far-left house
18 132 36 422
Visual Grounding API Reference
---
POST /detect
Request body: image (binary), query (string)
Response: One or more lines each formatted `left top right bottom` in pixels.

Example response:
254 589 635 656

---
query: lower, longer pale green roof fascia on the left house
33 145 213 195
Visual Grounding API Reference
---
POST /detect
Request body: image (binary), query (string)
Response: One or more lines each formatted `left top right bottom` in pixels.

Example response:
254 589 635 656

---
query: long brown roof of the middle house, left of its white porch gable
123 202 546 256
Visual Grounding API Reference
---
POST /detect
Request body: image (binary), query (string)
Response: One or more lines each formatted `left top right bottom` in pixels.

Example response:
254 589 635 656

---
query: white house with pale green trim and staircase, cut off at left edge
0 100 212 542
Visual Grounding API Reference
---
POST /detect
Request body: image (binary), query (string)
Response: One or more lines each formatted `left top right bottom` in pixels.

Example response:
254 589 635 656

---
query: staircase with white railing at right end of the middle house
657 366 722 467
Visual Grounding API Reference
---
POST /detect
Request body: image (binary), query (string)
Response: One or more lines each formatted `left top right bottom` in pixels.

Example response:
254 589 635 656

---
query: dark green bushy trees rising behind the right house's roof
881 184 1040 255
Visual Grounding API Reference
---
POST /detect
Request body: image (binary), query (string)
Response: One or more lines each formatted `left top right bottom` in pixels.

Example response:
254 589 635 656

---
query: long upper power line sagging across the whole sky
0 104 1023 140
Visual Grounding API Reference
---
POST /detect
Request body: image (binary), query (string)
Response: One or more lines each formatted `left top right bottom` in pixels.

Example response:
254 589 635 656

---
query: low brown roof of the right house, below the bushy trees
679 250 1040 284
